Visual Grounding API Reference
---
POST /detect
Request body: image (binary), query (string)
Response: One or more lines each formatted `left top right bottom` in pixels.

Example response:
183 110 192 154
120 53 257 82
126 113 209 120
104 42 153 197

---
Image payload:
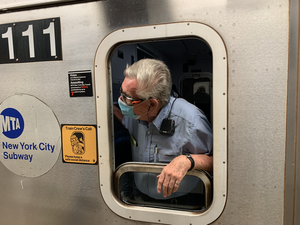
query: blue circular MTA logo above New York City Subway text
0 108 24 139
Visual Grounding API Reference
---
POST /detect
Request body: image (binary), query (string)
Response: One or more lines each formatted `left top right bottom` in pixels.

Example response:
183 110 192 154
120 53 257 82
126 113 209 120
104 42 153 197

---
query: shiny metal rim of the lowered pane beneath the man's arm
114 162 212 210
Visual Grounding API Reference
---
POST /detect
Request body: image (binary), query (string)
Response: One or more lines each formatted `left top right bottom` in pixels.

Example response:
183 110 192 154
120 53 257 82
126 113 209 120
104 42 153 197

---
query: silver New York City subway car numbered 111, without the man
0 0 300 225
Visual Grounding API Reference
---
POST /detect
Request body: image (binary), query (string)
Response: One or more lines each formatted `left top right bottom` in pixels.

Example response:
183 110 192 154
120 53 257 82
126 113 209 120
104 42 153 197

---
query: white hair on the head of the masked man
124 59 172 107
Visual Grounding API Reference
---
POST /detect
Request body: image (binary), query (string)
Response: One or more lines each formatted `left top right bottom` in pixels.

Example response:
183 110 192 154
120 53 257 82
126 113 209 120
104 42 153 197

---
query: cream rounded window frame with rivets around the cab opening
94 22 228 224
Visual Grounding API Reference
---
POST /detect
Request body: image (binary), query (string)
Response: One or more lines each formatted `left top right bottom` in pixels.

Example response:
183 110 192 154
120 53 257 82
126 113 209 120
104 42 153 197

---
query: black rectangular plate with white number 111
0 18 62 64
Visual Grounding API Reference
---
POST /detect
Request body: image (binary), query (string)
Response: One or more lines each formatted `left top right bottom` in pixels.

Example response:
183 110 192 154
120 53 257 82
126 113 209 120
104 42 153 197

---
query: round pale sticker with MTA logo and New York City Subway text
0 94 61 177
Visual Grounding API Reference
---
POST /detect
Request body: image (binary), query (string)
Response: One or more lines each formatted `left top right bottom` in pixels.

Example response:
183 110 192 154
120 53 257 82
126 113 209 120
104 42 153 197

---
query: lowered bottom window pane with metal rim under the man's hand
114 162 212 212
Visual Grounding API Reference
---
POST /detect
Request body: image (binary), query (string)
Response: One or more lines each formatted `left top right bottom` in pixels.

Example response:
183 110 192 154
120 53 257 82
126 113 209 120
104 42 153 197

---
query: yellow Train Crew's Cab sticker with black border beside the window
61 125 97 164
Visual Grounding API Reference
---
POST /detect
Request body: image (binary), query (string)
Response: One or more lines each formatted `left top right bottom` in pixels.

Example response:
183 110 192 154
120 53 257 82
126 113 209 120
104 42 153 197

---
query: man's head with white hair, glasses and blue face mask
120 59 172 122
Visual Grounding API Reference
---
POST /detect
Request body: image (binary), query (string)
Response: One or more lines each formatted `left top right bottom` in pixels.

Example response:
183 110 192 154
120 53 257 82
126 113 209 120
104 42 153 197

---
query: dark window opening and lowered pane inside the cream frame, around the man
111 38 212 211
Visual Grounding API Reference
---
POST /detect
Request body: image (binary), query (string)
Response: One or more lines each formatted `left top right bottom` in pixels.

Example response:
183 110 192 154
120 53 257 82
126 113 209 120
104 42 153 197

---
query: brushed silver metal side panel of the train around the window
0 0 289 225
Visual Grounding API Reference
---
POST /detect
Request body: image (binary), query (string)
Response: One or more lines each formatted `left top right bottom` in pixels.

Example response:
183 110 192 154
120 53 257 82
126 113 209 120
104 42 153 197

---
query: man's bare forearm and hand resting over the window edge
157 154 213 197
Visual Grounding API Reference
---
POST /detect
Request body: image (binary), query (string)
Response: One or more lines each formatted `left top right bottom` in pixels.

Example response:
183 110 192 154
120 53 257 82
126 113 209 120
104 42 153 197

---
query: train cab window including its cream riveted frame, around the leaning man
95 23 227 224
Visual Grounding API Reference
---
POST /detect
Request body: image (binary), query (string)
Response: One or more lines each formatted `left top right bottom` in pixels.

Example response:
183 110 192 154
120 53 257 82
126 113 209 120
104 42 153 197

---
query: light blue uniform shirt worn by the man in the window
122 97 213 199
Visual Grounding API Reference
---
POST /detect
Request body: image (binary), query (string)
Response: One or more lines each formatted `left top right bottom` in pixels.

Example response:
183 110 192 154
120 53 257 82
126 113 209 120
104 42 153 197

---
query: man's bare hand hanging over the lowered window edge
157 155 191 197
